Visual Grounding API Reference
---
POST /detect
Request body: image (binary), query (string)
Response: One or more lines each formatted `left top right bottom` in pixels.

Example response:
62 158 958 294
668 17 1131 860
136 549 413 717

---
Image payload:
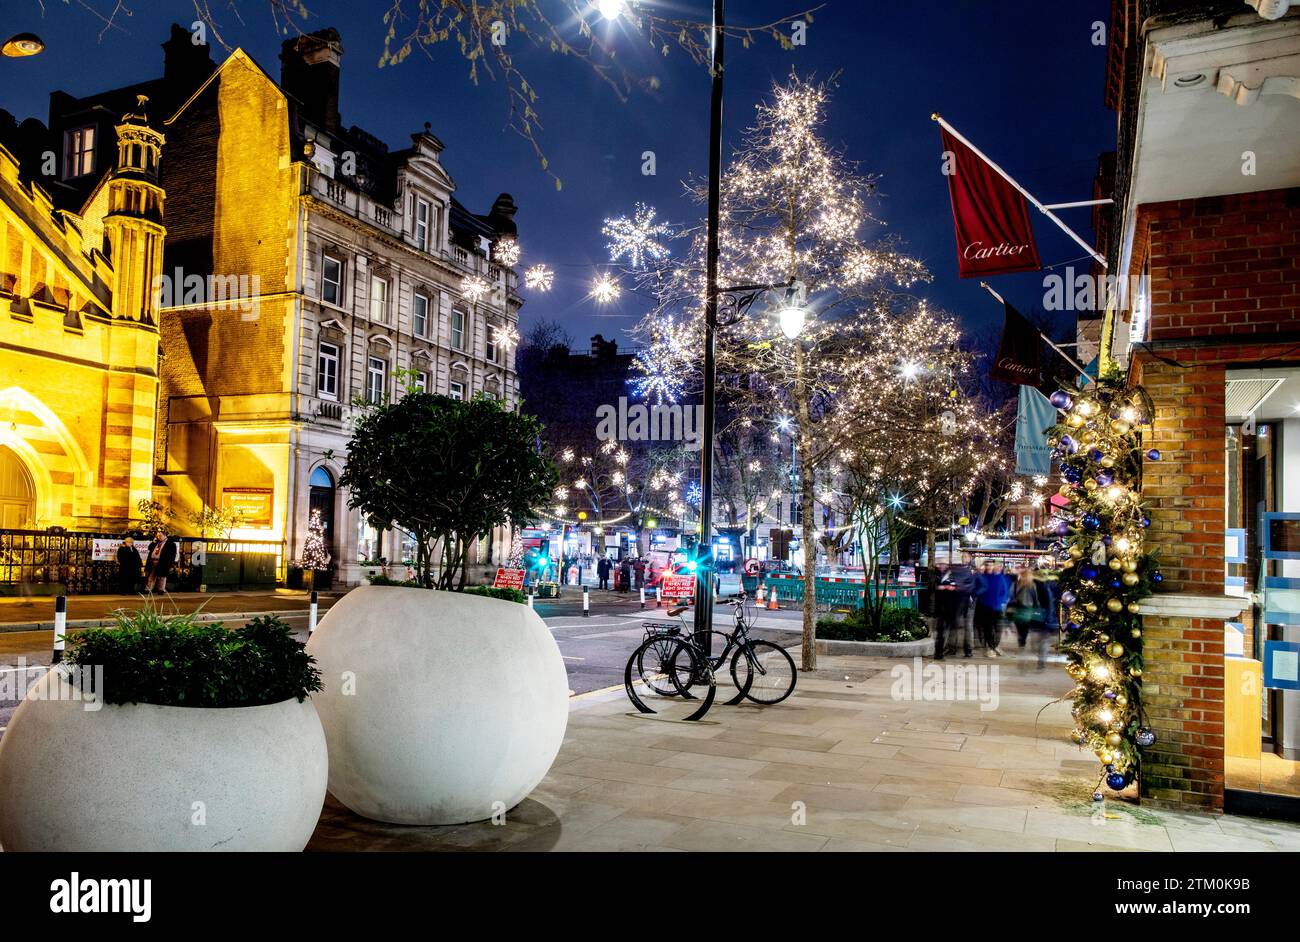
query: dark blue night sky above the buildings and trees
0 0 1115 347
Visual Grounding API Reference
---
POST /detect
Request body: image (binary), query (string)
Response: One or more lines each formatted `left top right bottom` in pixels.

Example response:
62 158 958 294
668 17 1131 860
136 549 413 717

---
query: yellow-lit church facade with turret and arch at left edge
0 95 166 531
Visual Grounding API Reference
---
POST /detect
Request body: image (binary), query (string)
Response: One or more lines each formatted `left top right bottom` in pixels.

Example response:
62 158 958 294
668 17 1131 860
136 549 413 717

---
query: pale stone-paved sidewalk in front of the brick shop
308 656 1300 851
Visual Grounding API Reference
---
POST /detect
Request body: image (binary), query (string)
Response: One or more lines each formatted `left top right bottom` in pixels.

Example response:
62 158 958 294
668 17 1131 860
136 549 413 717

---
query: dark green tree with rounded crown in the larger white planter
339 392 558 590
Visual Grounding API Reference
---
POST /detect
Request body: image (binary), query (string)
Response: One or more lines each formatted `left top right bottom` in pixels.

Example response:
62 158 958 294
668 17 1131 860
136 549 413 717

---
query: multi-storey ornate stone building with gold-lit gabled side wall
41 26 521 583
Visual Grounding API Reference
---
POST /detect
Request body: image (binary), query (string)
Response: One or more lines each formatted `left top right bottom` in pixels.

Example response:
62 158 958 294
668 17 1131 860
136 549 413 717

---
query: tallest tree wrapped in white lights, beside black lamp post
638 75 928 670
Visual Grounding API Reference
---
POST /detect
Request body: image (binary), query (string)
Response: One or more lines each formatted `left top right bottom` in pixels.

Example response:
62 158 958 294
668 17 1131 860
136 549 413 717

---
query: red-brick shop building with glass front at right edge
1088 0 1300 815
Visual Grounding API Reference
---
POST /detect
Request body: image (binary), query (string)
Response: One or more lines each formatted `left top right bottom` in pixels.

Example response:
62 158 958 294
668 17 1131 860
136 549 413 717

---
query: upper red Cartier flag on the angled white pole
939 126 1043 278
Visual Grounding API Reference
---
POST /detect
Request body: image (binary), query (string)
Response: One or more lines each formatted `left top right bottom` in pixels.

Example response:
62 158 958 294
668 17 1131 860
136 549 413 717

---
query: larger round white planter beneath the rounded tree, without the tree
307 586 568 824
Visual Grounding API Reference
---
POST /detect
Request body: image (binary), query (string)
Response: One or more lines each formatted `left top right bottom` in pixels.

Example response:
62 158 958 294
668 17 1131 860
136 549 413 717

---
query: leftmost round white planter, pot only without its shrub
0 673 329 851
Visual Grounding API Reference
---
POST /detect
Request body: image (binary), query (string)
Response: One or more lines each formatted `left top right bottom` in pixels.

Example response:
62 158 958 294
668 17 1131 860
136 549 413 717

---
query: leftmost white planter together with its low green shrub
0 608 328 851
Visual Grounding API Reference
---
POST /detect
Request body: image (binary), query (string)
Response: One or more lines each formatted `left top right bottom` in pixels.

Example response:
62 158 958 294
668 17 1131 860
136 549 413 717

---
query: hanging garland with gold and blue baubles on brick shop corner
1048 369 1161 802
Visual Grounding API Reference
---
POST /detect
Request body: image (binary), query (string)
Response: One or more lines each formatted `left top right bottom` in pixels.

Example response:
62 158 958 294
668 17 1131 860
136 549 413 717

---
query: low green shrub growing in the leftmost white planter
66 608 321 707
